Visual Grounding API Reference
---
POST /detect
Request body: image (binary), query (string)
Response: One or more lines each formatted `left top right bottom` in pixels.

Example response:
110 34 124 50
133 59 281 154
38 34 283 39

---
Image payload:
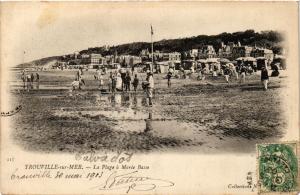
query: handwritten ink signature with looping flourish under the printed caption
92 171 175 193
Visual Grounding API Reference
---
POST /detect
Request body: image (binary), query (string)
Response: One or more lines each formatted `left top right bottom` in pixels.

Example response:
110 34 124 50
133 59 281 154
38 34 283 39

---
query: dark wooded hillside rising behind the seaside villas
18 30 284 66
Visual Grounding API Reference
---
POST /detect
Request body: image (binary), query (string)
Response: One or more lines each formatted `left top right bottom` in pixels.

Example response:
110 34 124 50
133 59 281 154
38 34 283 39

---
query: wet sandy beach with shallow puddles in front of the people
11 72 286 153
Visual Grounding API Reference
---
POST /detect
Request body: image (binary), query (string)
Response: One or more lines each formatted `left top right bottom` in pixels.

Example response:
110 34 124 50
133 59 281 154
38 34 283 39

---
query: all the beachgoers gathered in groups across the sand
21 60 279 105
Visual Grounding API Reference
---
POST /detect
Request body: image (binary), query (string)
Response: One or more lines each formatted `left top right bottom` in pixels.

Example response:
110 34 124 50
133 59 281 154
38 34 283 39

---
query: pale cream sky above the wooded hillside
1 2 295 65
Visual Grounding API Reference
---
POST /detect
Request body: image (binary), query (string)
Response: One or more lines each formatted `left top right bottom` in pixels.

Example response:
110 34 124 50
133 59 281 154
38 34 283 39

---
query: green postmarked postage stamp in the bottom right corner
257 143 299 193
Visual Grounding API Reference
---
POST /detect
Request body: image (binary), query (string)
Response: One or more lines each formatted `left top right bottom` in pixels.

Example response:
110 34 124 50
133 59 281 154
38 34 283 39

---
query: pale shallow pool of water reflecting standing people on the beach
53 94 204 139
